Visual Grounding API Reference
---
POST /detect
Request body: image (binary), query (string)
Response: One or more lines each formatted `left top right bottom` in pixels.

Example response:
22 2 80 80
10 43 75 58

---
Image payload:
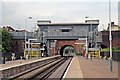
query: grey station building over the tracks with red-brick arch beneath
37 22 101 55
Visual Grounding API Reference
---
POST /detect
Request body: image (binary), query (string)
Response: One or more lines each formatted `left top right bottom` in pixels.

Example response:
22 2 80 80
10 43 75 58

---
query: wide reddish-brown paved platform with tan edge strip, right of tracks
65 56 119 80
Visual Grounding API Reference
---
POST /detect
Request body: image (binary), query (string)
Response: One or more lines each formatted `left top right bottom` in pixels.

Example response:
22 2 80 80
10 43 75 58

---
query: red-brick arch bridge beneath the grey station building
51 40 85 55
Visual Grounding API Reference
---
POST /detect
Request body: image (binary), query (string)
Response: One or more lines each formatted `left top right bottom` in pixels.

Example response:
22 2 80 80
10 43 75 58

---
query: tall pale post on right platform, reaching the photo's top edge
109 0 112 72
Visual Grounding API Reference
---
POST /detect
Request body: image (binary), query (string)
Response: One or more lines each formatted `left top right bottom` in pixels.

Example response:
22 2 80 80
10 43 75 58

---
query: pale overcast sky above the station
0 0 119 31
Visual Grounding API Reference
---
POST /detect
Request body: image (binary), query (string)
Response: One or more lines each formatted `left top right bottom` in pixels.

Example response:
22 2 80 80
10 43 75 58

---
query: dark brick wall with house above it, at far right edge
102 22 120 47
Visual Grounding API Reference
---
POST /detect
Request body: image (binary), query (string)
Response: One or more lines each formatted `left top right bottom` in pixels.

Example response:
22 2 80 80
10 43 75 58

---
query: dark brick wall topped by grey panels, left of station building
10 30 33 53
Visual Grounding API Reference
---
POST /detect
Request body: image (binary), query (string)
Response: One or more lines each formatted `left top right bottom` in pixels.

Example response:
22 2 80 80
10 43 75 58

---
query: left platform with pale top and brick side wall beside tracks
0 55 61 79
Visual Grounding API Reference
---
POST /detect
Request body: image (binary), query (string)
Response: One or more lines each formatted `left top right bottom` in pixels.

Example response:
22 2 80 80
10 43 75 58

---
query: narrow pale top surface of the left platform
0 55 60 70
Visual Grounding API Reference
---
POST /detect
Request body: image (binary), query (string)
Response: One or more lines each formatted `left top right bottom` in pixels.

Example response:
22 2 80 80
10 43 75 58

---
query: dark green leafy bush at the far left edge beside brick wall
2 29 11 52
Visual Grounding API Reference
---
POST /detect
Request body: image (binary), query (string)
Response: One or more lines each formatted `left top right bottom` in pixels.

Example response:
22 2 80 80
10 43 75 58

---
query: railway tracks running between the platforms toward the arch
10 57 72 80
